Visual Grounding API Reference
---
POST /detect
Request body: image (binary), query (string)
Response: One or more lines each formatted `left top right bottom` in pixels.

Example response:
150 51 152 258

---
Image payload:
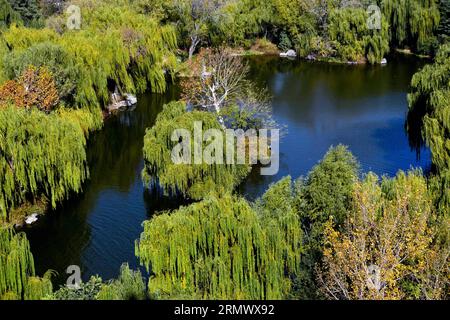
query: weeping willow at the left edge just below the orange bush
0 106 88 221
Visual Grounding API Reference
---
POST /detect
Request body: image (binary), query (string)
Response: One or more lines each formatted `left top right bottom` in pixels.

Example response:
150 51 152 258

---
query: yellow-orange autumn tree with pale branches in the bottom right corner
318 171 450 300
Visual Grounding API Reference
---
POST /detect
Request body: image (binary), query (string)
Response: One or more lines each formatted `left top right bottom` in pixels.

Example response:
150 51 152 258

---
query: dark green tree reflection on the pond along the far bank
249 55 424 99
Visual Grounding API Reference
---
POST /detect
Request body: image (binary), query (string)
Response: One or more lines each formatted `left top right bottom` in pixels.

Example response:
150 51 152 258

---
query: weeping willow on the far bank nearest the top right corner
381 0 439 50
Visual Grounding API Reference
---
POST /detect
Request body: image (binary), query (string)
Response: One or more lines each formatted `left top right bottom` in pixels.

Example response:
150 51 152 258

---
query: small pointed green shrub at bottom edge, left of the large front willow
97 263 146 300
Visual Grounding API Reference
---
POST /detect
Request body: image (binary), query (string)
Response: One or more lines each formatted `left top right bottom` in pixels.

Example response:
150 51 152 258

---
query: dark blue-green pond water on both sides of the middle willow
27 58 430 281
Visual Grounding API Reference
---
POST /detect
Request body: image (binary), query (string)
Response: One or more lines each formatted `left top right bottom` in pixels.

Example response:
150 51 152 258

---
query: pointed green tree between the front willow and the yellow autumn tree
296 145 359 299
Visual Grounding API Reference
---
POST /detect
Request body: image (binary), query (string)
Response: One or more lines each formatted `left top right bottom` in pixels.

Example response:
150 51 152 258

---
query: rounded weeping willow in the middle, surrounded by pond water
142 102 249 199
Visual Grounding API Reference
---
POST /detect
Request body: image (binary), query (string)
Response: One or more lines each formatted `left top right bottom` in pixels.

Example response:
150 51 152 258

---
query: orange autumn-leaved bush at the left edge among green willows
0 66 59 112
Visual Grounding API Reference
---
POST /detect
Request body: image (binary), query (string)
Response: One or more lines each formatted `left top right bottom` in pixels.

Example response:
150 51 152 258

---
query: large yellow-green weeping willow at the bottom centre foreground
136 180 302 299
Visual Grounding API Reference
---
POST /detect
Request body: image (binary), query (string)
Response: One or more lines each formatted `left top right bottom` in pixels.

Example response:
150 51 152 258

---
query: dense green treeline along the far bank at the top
134 0 448 63
